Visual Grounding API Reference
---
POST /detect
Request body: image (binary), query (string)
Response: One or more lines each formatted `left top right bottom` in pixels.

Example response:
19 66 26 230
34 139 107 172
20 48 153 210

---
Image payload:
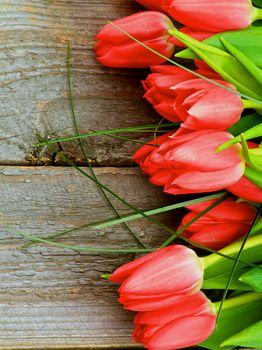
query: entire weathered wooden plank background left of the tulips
0 0 178 350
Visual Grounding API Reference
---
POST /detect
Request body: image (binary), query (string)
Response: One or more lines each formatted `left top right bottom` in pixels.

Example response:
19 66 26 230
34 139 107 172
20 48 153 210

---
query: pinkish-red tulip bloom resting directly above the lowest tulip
109 245 203 311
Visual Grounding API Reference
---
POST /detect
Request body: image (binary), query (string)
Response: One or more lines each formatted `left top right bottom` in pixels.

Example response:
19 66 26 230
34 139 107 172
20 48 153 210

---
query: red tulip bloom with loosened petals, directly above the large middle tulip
143 65 244 130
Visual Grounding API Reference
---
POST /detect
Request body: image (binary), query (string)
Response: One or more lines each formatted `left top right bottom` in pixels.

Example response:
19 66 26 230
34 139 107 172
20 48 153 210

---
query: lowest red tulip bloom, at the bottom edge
133 292 216 350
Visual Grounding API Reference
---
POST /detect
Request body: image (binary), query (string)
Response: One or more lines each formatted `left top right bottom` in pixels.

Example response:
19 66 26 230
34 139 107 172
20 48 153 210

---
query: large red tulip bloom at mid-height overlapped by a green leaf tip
133 129 245 194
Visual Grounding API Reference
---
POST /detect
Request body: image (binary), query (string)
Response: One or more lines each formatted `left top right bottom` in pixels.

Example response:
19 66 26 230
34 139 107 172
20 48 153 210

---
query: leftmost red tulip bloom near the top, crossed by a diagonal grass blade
95 11 175 68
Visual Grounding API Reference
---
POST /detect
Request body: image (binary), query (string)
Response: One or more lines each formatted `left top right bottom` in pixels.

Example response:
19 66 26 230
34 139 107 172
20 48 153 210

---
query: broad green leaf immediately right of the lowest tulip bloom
199 293 262 350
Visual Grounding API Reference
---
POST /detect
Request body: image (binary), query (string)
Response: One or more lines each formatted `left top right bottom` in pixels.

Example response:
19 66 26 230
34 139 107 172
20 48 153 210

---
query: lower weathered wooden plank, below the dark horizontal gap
0 166 175 349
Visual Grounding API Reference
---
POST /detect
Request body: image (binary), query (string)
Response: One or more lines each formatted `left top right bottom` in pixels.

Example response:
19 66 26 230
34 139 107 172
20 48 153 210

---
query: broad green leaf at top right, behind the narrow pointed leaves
176 26 262 68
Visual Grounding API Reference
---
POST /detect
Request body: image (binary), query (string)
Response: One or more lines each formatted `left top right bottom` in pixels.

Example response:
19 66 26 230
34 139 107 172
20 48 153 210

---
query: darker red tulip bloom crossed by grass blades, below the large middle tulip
178 198 257 250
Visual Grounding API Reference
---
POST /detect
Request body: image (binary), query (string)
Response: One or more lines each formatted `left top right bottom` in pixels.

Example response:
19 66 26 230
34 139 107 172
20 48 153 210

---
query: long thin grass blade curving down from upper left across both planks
67 43 146 248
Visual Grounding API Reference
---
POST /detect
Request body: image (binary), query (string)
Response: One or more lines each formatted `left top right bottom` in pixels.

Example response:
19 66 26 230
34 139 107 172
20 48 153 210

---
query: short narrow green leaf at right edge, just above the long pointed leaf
220 37 262 85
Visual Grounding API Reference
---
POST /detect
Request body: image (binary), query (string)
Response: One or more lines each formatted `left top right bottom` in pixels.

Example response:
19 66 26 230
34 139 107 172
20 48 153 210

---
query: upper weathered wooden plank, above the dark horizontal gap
0 0 164 165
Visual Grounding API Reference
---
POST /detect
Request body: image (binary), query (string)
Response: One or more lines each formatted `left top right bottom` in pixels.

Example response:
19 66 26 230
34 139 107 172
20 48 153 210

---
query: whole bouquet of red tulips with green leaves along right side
95 0 262 350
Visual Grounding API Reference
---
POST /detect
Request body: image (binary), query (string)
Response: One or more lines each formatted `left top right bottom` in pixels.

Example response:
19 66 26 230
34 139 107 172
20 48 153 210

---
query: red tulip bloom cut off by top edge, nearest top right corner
162 0 262 33
